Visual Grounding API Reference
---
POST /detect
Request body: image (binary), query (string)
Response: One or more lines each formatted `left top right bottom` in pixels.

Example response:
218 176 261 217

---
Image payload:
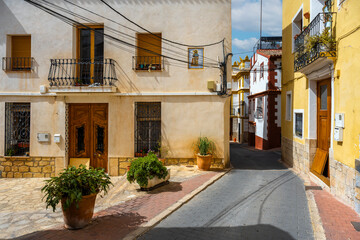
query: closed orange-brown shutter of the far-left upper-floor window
11 36 31 69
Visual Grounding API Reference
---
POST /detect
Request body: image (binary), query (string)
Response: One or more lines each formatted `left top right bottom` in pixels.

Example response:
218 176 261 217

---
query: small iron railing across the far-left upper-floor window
2 57 34 71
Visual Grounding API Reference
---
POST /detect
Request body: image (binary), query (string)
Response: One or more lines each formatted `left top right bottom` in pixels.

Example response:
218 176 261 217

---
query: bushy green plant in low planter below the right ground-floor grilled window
127 152 168 187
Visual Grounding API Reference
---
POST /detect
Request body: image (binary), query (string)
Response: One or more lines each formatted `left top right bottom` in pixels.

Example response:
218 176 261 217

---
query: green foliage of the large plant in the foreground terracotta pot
41 165 113 212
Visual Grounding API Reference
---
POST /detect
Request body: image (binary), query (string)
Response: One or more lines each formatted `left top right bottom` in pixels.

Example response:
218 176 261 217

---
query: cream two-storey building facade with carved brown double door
0 0 231 177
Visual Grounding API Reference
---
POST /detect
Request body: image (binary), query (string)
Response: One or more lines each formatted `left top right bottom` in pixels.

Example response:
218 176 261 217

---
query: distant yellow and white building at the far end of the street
230 56 250 143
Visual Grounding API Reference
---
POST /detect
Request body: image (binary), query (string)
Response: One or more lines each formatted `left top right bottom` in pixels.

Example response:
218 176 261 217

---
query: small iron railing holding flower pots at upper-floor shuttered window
132 56 164 71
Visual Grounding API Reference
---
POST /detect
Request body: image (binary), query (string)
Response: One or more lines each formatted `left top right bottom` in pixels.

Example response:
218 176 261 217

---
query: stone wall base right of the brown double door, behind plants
109 157 224 176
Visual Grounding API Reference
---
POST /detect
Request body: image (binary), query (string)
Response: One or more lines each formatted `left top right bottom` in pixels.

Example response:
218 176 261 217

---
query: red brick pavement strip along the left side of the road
20 172 219 240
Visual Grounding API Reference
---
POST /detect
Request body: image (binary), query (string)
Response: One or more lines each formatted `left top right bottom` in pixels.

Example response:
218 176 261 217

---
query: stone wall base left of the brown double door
0 157 55 178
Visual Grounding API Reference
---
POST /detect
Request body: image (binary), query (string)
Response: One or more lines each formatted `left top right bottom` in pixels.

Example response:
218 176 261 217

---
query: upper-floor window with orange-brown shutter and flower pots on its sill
134 33 163 71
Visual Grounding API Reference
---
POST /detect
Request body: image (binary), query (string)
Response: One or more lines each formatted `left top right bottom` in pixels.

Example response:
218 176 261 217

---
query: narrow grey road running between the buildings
140 144 313 240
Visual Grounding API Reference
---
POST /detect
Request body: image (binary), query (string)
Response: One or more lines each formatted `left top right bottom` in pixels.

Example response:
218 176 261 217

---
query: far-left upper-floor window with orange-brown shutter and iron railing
3 35 33 71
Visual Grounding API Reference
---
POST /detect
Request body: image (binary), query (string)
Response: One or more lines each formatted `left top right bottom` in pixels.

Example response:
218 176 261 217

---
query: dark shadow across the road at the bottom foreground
139 224 294 240
